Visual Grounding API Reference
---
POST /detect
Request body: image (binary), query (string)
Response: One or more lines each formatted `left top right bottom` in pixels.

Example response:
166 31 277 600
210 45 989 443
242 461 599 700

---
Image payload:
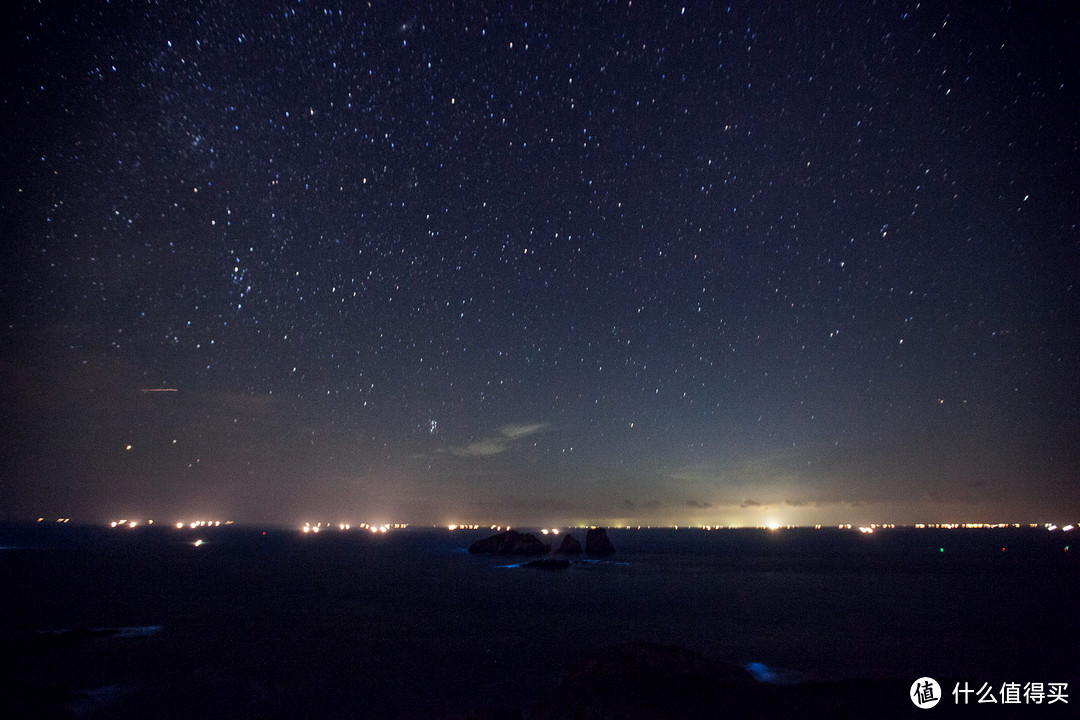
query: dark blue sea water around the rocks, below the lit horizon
0 526 1080 718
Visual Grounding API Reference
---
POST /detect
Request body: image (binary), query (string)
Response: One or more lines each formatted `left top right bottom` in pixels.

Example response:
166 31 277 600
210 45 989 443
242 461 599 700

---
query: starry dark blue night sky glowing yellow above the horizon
0 0 1080 525
